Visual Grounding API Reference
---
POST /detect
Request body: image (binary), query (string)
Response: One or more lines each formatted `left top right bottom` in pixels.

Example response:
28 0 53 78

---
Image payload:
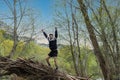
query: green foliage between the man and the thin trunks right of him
58 46 75 74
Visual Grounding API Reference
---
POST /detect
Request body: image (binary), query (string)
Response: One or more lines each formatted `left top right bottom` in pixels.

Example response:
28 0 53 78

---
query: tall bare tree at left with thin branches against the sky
4 0 35 57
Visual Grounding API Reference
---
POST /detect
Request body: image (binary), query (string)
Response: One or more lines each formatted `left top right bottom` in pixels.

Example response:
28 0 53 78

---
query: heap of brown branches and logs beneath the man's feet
0 57 88 80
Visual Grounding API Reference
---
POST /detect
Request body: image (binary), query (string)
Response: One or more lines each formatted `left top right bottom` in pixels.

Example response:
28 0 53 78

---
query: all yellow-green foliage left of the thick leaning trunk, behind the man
0 31 100 79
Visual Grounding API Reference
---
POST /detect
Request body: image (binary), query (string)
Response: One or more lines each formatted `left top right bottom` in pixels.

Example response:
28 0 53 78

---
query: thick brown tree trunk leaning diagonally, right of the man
78 0 112 80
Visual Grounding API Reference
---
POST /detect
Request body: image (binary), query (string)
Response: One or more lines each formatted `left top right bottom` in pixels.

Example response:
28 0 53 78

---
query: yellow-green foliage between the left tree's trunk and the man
15 42 49 60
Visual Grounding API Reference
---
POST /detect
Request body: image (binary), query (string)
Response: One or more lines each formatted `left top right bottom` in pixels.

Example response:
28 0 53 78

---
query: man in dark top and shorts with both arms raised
42 27 58 70
